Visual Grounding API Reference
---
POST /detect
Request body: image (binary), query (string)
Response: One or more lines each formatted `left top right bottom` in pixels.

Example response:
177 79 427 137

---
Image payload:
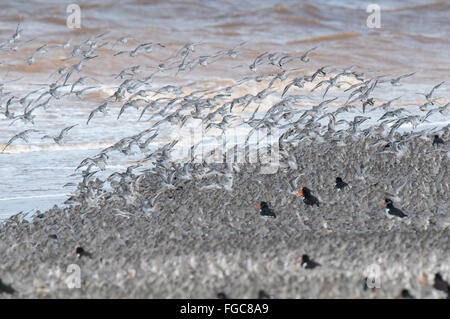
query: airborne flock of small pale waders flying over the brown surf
0 25 450 154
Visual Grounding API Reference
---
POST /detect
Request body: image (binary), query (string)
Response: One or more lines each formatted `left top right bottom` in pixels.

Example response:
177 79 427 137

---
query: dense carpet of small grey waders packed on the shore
0 131 450 298
